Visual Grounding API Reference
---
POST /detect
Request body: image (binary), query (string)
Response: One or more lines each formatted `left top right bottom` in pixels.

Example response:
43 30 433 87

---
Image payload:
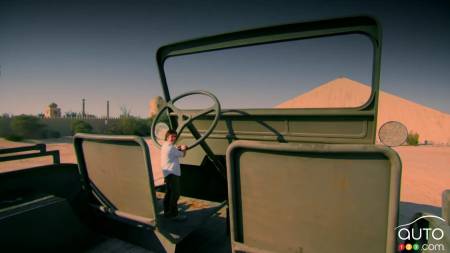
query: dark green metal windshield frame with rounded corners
156 16 381 114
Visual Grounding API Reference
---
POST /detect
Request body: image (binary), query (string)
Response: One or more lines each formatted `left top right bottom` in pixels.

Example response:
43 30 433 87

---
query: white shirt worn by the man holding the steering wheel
161 142 184 177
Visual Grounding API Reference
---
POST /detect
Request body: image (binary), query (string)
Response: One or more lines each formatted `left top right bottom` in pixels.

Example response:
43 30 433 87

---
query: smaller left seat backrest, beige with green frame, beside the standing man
74 134 157 225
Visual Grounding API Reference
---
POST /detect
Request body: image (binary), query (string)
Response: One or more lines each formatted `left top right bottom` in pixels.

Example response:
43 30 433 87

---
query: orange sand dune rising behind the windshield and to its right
276 77 450 145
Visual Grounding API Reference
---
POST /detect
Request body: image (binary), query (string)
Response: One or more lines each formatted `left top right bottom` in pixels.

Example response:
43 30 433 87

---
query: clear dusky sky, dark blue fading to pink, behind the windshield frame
0 0 450 116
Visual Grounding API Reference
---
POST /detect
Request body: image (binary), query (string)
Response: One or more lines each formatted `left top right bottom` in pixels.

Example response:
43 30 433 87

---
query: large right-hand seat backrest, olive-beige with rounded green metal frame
227 141 401 253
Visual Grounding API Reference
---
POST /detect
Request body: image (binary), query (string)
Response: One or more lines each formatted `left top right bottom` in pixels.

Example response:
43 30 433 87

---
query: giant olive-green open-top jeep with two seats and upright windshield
0 17 448 253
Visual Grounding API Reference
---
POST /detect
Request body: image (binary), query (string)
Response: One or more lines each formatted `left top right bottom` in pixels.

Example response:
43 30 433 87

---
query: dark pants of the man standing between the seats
164 174 180 217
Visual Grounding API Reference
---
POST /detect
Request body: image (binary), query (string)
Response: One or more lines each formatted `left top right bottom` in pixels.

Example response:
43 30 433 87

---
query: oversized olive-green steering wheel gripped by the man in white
151 90 220 149
